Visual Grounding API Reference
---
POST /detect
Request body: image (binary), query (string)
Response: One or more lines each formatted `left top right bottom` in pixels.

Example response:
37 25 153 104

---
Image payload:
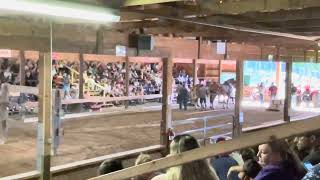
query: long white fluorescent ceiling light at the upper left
0 0 120 23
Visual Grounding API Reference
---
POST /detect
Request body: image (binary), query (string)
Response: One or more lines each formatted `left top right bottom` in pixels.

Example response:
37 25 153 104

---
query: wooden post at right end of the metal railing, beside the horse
232 59 243 137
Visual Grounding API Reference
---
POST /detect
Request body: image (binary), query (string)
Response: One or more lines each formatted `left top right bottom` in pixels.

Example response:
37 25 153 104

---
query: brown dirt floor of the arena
0 105 317 177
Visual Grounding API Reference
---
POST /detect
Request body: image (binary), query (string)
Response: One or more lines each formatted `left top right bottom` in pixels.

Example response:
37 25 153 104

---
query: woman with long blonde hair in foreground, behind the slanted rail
166 135 219 180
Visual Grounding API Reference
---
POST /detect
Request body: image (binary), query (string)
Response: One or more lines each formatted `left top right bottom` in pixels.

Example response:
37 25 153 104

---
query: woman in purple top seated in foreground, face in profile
254 138 300 180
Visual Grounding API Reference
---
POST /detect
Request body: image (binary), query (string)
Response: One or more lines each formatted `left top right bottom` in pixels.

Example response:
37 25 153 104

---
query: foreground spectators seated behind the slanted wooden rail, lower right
98 133 320 180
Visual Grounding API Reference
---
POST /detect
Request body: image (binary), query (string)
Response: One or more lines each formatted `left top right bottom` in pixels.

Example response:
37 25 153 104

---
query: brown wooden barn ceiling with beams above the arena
0 0 320 49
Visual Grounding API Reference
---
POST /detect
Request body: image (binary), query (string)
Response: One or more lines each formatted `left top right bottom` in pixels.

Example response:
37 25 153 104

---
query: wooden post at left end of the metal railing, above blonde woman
160 57 173 150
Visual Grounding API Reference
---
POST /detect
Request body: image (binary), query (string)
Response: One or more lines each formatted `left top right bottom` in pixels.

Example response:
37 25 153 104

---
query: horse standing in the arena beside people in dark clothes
209 79 236 109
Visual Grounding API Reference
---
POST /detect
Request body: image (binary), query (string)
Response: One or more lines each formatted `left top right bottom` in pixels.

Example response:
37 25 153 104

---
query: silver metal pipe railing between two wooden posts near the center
172 113 234 142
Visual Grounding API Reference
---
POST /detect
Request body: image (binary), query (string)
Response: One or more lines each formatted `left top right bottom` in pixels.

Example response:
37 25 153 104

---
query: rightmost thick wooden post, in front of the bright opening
283 58 292 122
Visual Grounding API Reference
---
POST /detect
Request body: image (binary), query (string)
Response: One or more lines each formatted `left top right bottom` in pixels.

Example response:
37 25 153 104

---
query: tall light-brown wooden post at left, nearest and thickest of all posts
37 53 52 180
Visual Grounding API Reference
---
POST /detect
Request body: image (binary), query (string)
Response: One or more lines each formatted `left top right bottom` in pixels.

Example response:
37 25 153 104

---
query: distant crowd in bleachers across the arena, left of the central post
0 59 162 97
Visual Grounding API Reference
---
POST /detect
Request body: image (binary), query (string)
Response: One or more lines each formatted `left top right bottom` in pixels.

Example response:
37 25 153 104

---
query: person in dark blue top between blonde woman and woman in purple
211 137 239 180
